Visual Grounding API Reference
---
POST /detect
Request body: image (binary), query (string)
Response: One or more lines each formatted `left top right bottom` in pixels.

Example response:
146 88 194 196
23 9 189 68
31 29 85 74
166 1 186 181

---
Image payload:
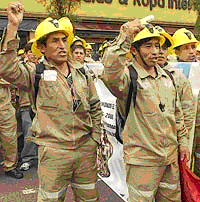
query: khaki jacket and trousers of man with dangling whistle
102 30 188 202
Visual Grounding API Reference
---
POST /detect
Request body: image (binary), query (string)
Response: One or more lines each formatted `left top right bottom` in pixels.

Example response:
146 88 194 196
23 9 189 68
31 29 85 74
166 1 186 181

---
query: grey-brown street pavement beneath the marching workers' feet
0 152 124 202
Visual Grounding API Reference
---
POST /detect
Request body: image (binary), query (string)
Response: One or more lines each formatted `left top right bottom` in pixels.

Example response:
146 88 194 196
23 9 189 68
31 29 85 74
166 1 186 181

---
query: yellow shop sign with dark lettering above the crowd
0 0 197 24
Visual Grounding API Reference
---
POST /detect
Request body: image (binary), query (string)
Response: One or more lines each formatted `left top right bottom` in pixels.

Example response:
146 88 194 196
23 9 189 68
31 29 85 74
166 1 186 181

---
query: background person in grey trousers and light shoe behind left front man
18 41 38 171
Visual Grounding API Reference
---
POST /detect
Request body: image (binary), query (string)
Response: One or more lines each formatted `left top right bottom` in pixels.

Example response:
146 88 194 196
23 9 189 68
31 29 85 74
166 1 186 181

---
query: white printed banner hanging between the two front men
86 63 128 201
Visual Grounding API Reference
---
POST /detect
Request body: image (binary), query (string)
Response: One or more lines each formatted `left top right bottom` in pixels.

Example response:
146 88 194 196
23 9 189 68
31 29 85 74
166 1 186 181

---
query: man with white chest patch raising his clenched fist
0 2 102 202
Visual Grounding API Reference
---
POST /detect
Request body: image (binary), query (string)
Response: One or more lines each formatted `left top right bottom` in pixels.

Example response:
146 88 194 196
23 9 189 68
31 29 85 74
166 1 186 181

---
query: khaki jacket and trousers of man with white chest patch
0 39 102 202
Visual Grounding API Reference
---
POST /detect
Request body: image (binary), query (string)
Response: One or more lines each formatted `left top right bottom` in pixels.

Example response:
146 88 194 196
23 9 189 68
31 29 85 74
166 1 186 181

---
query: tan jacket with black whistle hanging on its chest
102 32 188 166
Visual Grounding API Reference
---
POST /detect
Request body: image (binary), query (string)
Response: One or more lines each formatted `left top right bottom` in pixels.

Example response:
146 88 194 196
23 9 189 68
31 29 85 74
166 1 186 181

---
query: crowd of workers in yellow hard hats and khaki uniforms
0 2 200 202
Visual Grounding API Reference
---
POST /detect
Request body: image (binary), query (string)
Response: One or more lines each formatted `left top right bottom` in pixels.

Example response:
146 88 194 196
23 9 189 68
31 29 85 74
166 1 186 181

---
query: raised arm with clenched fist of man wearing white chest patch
0 2 34 91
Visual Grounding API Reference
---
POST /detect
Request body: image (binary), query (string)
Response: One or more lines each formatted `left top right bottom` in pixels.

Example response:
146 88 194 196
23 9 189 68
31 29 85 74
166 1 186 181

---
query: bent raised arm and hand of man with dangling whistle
101 19 144 98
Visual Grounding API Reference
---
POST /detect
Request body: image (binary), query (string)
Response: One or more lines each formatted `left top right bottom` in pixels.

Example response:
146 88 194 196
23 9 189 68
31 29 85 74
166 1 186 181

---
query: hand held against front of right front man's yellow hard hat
121 19 145 38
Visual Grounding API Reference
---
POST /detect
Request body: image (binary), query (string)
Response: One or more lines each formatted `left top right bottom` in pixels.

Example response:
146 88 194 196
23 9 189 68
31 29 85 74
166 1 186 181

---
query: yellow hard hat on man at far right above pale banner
172 28 198 48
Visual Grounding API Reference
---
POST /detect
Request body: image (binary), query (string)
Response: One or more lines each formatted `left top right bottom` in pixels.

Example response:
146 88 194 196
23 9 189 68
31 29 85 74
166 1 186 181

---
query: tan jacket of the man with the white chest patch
0 39 102 149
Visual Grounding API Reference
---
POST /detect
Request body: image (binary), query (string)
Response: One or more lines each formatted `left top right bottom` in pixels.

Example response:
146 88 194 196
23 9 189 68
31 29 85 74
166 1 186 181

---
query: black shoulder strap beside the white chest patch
34 62 45 103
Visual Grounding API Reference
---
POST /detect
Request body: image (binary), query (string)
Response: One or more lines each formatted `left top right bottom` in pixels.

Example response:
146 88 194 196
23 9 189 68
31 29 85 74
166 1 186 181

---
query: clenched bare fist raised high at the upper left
7 2 24 26
